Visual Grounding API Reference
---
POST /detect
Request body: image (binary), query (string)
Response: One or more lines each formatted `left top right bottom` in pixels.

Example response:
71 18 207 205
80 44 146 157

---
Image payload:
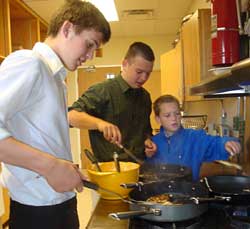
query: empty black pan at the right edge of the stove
203 175 250 205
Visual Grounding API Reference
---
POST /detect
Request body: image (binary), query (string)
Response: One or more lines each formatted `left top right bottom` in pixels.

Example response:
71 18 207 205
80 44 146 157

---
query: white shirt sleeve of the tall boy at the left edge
0 54 39 140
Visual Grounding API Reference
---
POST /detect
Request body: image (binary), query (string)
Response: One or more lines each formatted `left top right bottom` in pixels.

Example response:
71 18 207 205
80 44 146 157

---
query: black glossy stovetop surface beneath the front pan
129 204 250 229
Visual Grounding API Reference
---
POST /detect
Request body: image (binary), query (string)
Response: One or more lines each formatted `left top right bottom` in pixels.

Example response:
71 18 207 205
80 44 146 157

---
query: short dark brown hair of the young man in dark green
125 42 155 62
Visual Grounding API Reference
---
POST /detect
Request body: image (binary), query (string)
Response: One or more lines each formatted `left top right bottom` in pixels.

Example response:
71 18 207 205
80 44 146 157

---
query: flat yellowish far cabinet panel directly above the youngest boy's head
161 42 183 103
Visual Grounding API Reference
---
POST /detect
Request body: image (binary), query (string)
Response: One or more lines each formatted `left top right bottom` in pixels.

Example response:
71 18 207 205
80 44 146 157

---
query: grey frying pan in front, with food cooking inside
109 181 217 222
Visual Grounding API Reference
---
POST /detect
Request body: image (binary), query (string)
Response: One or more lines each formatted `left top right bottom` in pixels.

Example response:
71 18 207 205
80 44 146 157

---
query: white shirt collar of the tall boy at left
33 42 67 80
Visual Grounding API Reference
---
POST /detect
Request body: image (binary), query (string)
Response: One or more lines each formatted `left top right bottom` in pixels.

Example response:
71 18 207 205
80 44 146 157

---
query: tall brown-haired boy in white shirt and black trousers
0 0 111 229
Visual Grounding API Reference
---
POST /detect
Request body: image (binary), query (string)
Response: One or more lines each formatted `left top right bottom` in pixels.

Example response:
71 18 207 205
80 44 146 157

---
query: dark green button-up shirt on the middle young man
70 75 152 161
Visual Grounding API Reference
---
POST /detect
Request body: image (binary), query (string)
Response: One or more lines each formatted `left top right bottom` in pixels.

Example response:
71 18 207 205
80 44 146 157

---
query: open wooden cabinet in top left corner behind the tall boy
0 0 47 62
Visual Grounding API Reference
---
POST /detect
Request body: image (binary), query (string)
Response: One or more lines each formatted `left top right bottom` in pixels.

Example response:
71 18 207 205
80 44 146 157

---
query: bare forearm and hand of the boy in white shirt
0 137 84 192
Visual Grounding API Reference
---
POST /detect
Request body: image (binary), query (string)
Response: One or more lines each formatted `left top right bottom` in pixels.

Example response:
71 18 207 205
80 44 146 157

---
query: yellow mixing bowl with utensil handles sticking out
87 161 140 200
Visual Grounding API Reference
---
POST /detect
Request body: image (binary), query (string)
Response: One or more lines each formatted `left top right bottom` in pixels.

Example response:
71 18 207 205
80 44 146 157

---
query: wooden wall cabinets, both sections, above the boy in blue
161 9 212 102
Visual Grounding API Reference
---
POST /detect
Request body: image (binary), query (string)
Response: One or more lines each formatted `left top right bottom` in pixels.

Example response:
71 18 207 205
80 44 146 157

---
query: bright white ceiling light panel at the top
87 0 119 21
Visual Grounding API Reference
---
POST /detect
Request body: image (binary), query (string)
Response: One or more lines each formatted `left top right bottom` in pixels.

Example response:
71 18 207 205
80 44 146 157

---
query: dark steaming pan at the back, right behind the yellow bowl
139 162 192 182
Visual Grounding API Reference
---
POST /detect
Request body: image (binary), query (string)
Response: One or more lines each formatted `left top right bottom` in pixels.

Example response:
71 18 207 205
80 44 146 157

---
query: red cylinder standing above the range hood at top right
211 0 240 66
